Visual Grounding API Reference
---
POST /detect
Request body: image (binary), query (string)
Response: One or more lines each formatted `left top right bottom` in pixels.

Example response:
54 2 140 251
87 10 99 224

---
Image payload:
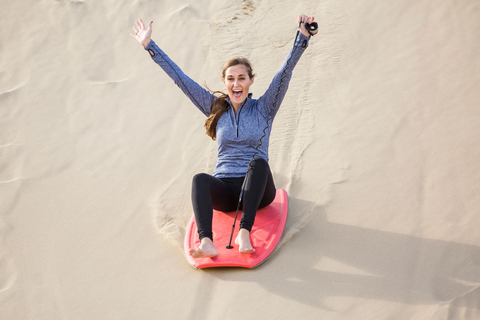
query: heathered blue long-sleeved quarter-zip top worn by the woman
145 32 310 178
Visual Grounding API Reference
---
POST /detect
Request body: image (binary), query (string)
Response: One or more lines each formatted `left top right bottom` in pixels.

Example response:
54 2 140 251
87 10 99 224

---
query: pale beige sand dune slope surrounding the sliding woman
0 0 480 320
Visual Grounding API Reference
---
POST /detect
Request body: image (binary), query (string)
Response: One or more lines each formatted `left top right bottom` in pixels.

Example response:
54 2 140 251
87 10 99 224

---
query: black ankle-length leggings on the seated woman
192 158 276 240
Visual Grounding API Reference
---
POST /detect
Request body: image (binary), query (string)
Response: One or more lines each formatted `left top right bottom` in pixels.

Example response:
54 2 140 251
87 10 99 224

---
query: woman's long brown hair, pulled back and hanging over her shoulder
205 57 255 140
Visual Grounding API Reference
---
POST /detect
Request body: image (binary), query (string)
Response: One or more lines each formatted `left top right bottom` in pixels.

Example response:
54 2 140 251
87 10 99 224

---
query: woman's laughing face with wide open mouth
223 64 253 108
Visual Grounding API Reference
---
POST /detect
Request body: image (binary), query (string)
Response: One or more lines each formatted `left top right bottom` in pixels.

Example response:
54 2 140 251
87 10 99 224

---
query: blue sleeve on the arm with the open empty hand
145 40 215 117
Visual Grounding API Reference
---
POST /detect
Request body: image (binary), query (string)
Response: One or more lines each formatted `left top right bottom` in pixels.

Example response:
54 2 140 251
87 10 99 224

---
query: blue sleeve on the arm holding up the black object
258 32 310 118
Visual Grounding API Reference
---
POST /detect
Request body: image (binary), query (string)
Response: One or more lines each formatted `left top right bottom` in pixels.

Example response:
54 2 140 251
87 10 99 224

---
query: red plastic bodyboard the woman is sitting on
184 189 288 269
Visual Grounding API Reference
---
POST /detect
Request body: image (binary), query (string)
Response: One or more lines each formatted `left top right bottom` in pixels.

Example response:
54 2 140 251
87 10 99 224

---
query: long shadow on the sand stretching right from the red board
195 199 480 309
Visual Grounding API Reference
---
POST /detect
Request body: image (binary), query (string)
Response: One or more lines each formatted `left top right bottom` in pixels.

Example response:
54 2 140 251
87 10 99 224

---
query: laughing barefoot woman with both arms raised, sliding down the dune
132 14 314 258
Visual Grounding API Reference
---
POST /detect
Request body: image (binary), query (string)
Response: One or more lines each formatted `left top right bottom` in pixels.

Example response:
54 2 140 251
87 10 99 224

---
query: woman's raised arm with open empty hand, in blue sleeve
131 19 215 117
